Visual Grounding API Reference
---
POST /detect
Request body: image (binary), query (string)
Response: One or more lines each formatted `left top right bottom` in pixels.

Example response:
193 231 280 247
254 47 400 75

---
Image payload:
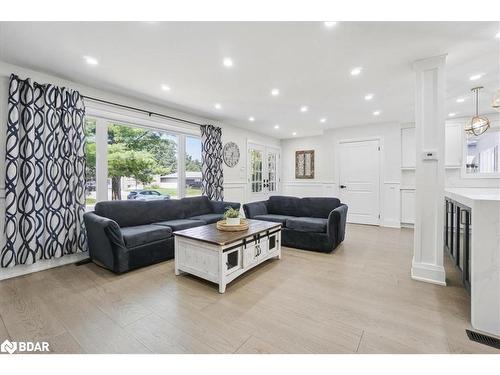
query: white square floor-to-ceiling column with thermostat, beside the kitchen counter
411 55 446 285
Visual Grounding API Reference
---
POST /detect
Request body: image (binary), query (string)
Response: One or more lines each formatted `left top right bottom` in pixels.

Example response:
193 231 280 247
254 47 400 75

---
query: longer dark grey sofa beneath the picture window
84 197 240 273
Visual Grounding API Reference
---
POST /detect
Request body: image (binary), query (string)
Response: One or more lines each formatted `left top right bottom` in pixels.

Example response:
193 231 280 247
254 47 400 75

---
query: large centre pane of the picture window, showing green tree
108 123 178 200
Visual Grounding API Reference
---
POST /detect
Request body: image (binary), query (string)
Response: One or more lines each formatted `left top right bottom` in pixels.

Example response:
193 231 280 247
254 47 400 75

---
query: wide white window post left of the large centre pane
95 118 111 202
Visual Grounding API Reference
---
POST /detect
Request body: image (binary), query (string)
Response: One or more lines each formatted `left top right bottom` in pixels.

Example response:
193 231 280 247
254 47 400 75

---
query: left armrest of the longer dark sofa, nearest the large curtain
83 212 125 270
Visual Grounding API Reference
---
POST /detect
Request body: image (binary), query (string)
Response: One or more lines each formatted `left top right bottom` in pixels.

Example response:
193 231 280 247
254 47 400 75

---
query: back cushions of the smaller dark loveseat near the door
268 196 340 219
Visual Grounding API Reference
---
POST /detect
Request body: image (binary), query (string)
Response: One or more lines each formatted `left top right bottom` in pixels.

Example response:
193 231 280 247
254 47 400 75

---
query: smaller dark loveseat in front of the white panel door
243 196 347 252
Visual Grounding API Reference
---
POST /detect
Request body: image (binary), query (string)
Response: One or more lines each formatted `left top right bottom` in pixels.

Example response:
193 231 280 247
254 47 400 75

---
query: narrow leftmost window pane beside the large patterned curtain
84 119 96 211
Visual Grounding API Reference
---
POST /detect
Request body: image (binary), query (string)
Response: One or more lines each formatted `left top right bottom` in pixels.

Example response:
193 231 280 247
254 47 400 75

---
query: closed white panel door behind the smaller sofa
339 140 380 225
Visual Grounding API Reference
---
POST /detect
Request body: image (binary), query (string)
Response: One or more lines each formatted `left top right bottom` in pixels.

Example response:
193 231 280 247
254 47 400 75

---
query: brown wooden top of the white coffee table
174 219 281 246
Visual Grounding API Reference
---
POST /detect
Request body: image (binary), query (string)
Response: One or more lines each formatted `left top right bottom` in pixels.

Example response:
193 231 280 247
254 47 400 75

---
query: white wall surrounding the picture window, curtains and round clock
0 61 280 280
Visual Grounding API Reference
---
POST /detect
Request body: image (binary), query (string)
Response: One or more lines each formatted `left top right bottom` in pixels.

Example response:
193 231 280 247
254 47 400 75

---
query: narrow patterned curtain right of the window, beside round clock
201 125 224 201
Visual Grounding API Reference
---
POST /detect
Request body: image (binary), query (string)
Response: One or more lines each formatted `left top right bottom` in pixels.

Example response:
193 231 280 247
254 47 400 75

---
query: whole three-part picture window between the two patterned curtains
85 113 201 204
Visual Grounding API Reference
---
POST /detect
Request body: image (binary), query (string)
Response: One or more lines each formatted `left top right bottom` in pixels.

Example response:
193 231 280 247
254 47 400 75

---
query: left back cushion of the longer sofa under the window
95 199 186 227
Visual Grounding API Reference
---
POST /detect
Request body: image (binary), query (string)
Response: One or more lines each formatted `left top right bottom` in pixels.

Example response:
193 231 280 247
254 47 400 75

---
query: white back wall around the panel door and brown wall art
281 123 401 227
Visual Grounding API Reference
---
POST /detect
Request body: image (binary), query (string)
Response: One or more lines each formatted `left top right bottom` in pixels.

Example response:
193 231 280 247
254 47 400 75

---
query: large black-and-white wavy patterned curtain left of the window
0 75 86 267
